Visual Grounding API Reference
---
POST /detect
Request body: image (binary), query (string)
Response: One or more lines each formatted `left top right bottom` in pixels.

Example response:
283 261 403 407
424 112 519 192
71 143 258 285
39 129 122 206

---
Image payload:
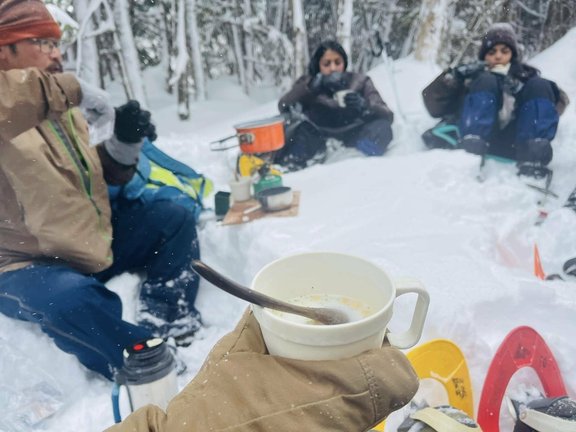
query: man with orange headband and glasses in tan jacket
0 0 201 378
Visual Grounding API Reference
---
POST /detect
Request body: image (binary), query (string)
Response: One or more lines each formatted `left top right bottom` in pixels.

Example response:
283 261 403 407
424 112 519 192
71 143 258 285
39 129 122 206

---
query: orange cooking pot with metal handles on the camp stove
211 116 284 153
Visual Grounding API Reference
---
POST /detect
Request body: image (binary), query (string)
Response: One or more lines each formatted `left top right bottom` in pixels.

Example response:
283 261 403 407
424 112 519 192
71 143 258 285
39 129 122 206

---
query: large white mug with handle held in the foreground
251 252 430 360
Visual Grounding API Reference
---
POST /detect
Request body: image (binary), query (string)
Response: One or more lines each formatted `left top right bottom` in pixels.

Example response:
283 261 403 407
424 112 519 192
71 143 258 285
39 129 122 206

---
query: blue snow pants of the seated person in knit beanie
459 72 559 164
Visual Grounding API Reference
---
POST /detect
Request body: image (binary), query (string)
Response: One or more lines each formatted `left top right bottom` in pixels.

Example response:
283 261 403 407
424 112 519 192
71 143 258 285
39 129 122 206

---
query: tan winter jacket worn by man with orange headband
0 69 130 273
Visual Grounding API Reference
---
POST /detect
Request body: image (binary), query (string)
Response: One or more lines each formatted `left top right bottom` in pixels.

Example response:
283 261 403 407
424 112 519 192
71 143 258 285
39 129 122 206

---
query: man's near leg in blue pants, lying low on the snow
0 265 151 379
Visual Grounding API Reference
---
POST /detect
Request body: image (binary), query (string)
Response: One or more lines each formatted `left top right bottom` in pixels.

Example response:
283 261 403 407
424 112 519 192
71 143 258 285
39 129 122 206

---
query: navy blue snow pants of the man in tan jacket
0 197 198 379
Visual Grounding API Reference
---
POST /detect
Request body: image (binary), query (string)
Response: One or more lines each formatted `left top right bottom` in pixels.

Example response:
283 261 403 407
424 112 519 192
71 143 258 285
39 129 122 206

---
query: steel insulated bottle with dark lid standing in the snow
112 338 178 423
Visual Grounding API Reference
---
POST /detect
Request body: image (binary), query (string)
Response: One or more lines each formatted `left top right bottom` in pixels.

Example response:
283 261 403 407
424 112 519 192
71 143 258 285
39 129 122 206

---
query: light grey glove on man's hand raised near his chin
78 79 115 144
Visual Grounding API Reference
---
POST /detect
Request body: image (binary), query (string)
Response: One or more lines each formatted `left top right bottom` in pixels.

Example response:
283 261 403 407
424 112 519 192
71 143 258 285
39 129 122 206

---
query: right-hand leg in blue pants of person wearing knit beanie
515 77 559 166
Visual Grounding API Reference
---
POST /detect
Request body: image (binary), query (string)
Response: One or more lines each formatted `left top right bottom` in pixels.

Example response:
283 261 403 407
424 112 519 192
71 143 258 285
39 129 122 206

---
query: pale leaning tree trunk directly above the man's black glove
114 0 148 108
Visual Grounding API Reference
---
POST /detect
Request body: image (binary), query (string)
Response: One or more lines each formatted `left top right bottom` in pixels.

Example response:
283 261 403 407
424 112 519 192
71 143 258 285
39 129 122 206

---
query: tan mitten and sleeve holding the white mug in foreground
107 313 418 432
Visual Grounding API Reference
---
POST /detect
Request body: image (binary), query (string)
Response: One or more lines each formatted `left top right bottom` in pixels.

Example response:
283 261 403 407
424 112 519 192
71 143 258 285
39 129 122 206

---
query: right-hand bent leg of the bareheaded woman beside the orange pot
344 119 392 156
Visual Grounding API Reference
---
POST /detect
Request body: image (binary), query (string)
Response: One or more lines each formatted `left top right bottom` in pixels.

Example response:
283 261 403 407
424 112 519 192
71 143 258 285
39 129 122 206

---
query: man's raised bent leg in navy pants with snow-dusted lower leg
96 200 202 344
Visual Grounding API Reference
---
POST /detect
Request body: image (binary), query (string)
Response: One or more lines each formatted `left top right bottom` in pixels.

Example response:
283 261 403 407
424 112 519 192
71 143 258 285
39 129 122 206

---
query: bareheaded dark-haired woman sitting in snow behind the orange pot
275 40 394 171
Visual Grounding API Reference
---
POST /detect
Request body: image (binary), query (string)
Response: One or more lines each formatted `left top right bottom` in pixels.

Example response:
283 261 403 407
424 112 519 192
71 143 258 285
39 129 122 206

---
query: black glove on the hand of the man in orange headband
114 100 158 144
